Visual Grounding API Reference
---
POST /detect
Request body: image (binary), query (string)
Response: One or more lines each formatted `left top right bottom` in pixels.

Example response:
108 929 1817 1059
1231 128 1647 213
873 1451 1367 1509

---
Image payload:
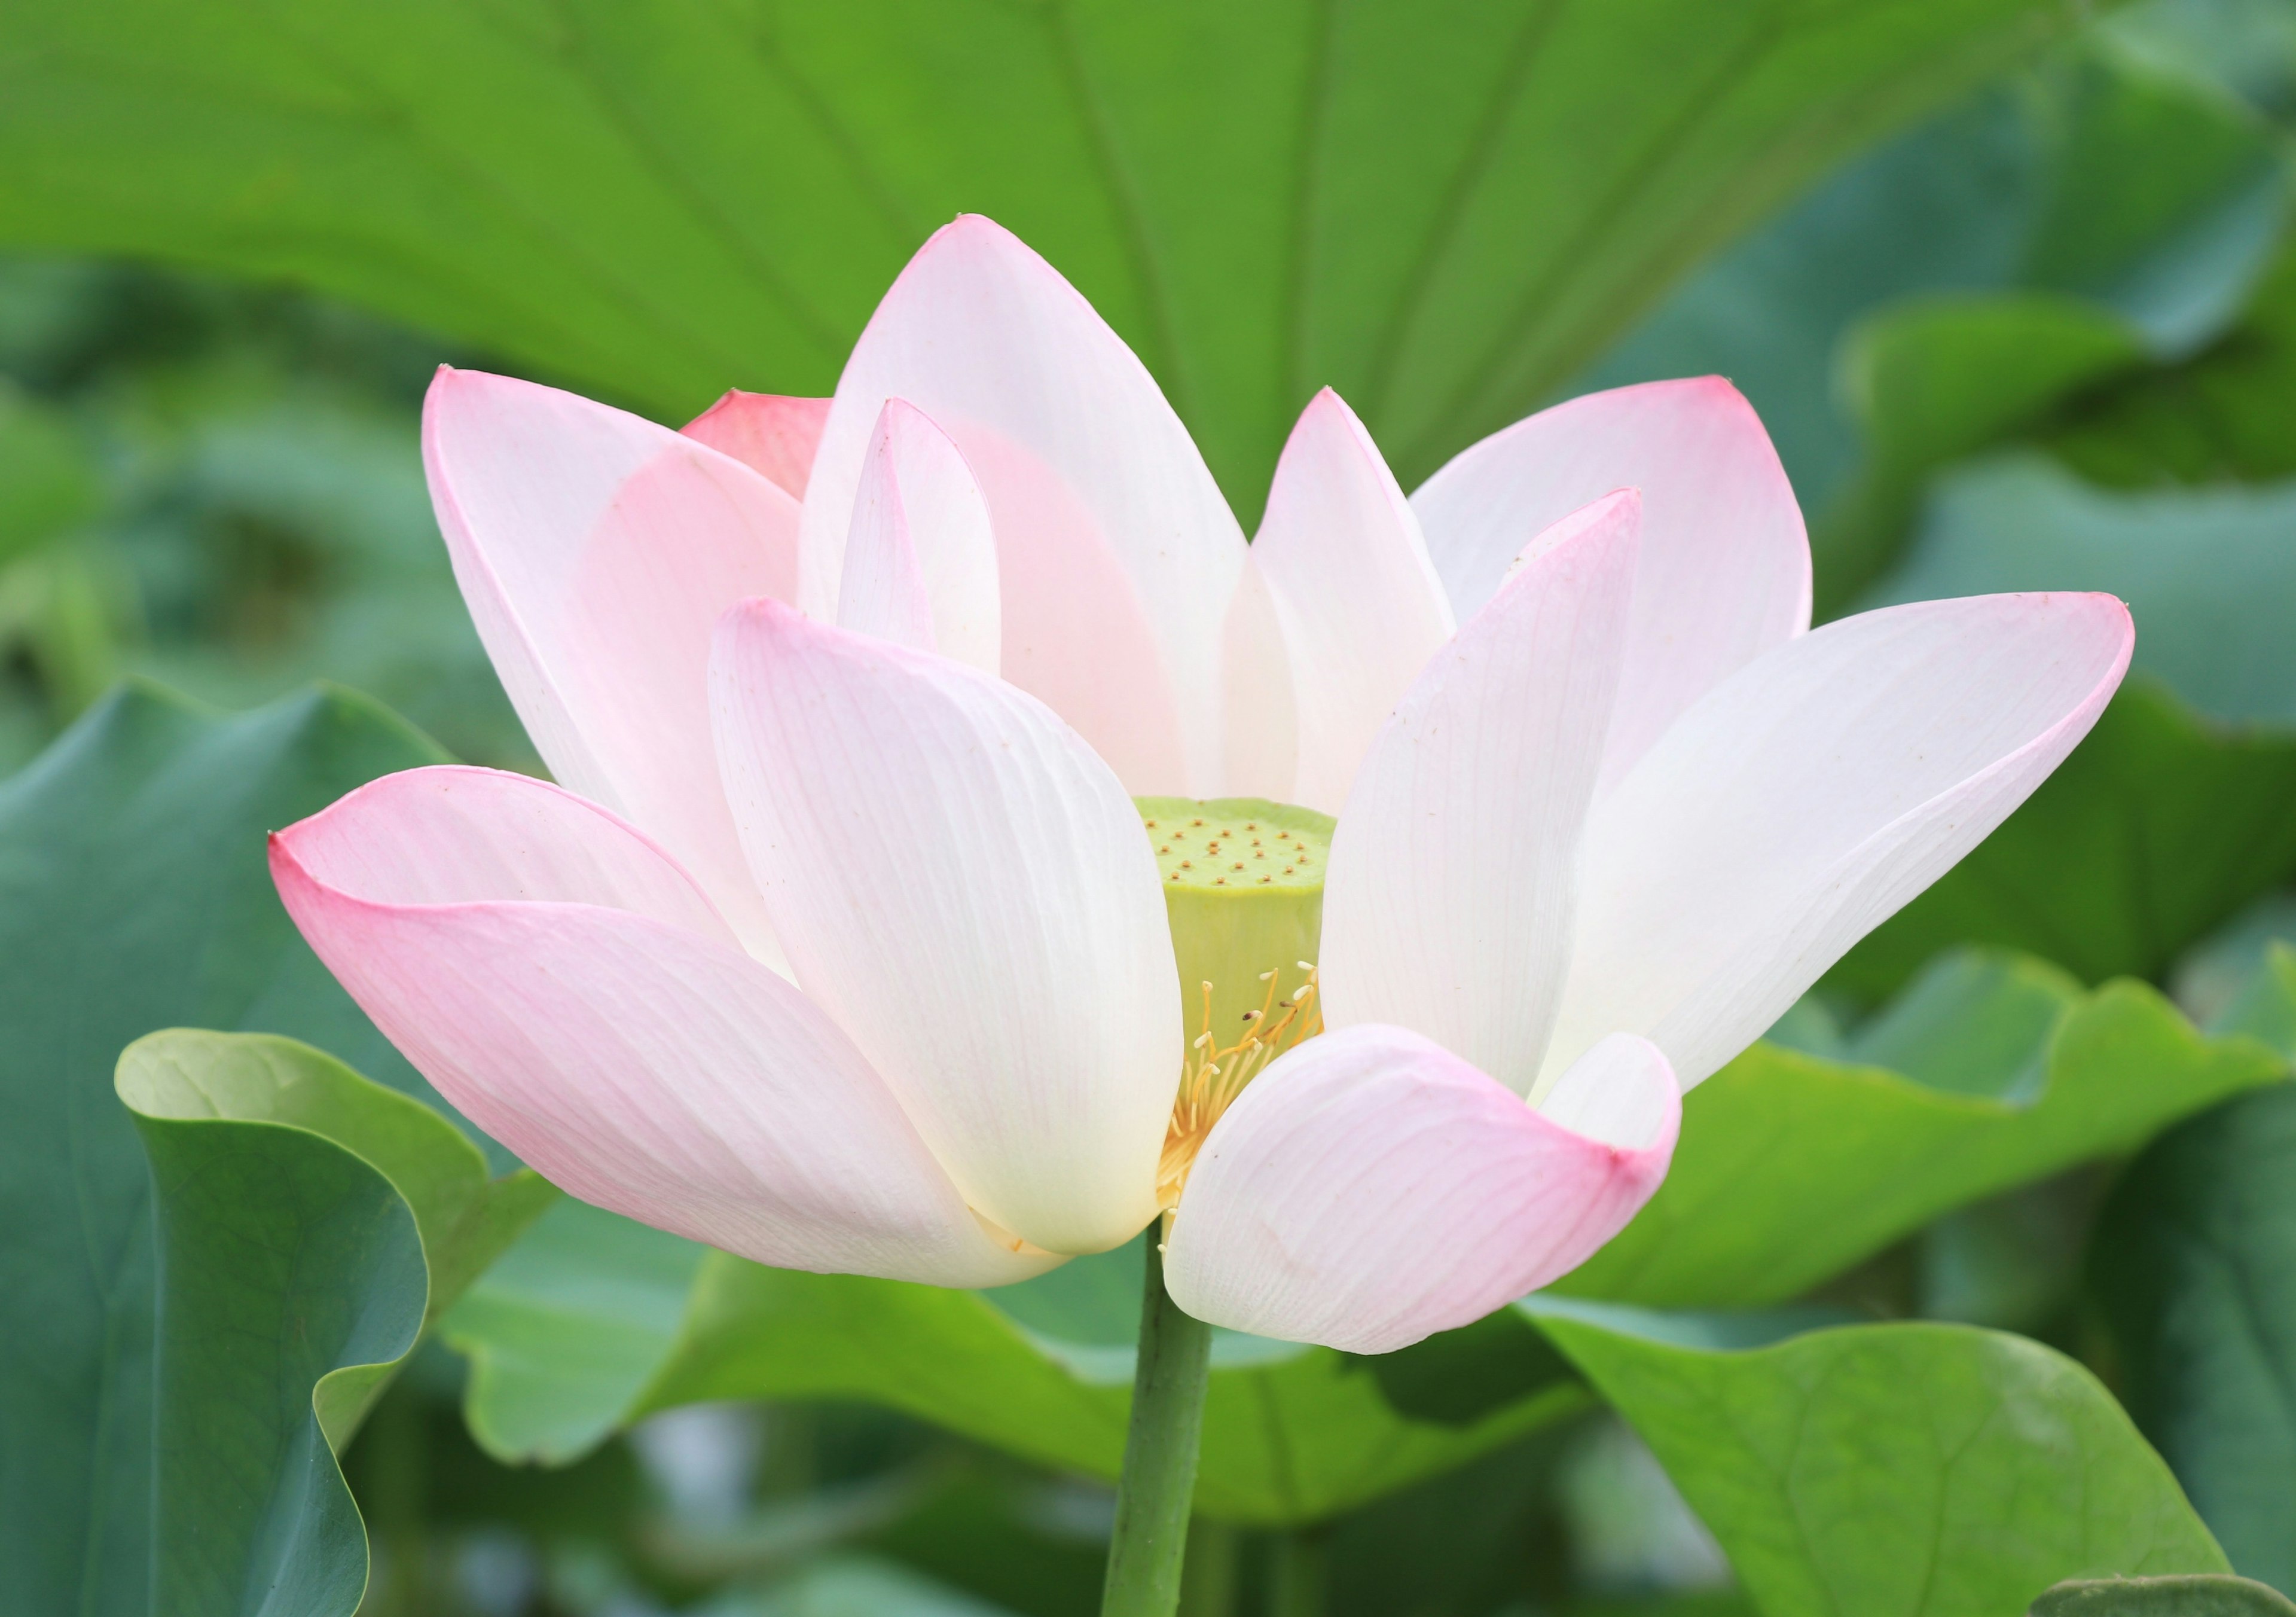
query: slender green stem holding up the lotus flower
1100 1231 1213 1617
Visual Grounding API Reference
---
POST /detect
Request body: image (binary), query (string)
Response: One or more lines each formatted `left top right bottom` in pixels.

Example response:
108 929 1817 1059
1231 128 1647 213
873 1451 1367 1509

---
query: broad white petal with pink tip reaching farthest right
1543 595 2133 1084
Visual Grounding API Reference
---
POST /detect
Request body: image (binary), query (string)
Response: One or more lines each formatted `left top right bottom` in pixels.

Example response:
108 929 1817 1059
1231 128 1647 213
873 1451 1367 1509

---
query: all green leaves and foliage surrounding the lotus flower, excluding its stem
0 0 2296 1617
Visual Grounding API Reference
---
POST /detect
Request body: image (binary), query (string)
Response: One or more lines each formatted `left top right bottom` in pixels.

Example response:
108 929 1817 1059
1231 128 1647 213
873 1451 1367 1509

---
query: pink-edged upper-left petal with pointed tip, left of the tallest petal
423 368 796 958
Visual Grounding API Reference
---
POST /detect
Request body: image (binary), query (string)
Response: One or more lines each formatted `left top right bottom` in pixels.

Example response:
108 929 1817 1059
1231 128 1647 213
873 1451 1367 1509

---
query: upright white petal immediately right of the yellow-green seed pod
1320 492 1637 1093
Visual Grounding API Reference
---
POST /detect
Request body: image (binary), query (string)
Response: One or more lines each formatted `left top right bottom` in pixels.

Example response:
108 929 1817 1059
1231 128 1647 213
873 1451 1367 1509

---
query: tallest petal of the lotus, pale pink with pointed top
804 216 1244 797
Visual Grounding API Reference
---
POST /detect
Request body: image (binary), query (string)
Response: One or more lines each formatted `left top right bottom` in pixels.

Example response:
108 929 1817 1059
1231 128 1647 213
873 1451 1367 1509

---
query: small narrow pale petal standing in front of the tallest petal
838 399 999 673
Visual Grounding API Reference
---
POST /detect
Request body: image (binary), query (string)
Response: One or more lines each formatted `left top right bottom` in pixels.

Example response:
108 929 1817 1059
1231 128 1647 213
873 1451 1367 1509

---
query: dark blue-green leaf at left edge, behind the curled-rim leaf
0 687 468 1617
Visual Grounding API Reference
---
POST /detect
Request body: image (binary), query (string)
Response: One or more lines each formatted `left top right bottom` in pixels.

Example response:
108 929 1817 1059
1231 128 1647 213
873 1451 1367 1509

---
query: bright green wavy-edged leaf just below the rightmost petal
1557 956 2287 1307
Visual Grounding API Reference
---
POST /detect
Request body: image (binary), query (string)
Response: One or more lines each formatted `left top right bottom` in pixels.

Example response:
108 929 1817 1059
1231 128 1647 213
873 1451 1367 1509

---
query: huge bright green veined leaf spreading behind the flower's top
0 0 2069 505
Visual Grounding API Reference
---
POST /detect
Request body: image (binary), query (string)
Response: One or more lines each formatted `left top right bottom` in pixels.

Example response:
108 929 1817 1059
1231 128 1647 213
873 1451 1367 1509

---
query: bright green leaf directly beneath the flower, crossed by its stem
443 1204 1584 1525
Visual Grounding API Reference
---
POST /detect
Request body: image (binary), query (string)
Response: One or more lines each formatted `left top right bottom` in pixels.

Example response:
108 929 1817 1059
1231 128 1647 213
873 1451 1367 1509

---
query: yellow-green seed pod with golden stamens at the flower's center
1137 797 1332 1210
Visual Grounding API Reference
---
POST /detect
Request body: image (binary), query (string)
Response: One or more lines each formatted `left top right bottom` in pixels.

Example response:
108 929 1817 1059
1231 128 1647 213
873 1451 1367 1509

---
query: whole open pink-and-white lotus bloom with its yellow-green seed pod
273 218 2131 1350
